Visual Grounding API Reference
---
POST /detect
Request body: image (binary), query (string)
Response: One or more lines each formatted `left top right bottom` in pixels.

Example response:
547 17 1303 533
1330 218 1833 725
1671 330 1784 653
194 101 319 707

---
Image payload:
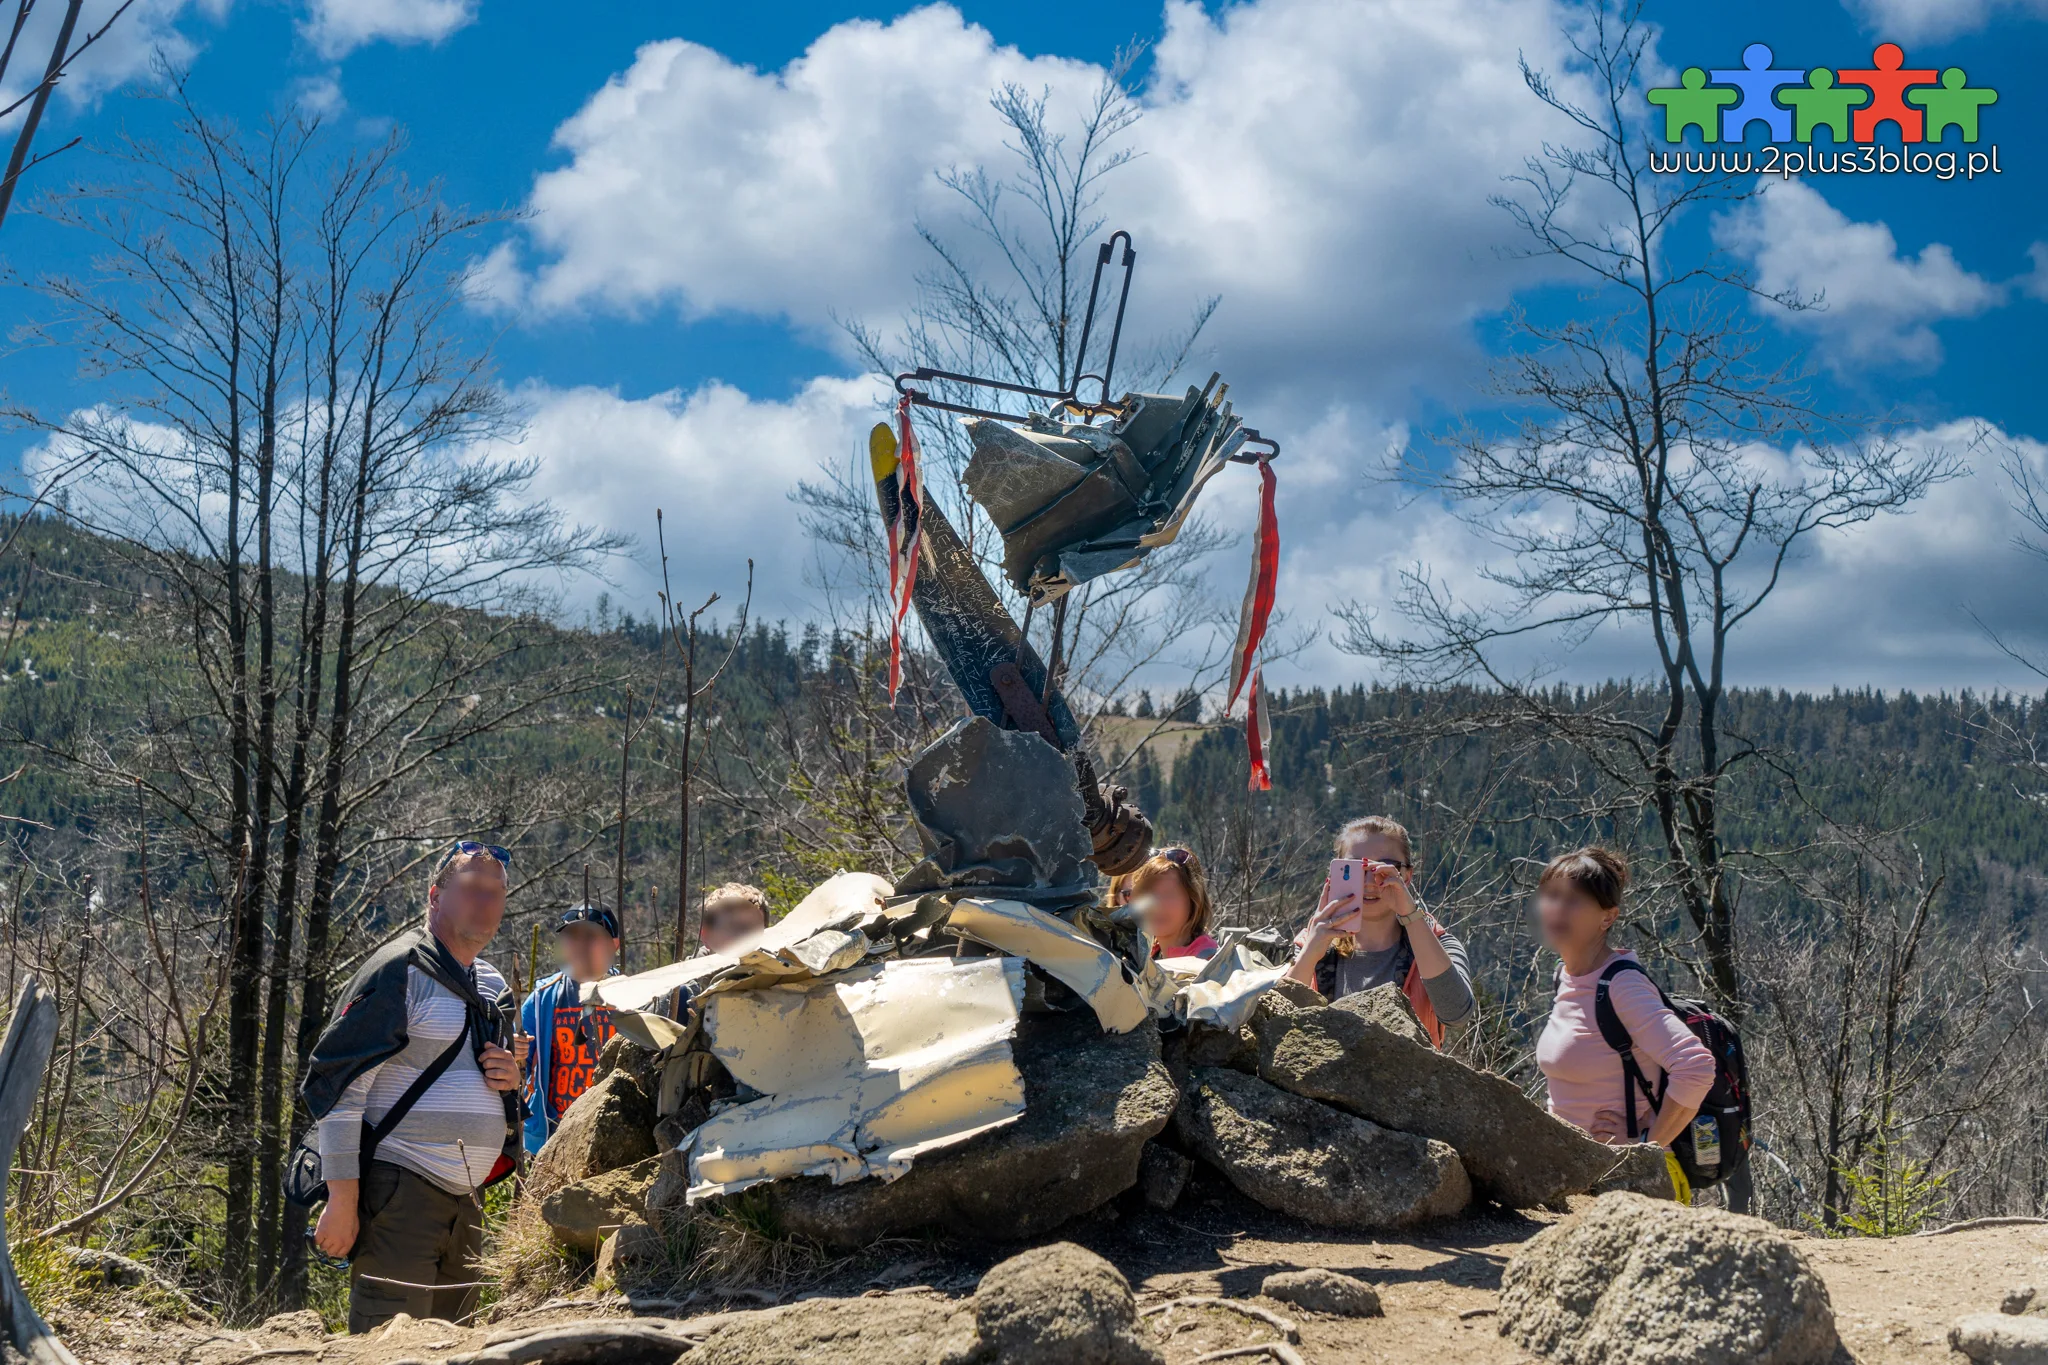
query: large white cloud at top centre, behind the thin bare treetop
479 0 1605 405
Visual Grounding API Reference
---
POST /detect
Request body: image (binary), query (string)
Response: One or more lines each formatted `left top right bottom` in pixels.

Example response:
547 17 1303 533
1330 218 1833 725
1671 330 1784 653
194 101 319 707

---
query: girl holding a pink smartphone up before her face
1288 814 1475 1048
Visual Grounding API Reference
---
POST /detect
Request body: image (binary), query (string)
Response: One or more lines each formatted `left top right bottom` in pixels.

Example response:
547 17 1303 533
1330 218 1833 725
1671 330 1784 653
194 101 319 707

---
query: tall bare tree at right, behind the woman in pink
1339 4 1958 1009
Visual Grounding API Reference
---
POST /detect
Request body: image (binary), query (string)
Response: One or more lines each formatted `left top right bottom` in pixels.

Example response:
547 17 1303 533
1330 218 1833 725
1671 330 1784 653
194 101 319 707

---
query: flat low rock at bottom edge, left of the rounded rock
684 1295 975 1365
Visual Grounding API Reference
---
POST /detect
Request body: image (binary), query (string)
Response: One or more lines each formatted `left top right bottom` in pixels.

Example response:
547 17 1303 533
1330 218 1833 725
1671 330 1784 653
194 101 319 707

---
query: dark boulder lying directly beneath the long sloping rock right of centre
1178 1066 1473 1228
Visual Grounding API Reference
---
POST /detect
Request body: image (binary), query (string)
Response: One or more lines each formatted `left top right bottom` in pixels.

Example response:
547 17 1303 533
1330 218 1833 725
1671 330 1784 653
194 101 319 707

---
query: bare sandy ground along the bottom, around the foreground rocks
57 1183 2048 1365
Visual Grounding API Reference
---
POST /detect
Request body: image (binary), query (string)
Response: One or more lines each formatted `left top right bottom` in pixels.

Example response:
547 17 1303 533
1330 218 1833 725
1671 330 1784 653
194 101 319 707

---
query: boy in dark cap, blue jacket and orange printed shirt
520 905 618 1152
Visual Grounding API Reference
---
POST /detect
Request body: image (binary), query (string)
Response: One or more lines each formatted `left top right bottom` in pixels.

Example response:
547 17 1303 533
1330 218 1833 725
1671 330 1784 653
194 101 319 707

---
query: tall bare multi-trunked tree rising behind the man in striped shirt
16 80 618 1308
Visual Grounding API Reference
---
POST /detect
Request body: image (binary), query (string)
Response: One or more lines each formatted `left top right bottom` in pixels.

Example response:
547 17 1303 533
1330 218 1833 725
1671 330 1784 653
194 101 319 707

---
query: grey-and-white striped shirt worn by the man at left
319 962 506 1195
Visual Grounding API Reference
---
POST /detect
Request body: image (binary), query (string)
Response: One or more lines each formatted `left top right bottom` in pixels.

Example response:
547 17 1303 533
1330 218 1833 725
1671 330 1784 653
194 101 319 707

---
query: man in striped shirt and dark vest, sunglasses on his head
303 839 526 1332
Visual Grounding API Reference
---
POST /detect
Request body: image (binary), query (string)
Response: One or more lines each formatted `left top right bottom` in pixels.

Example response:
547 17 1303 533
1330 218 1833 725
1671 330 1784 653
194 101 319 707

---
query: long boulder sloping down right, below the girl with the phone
1249 993 1669 1209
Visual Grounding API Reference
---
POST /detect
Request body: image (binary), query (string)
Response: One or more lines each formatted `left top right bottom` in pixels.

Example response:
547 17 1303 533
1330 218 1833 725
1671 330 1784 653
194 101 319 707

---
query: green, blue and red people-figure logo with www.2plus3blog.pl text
1645 43 1999 178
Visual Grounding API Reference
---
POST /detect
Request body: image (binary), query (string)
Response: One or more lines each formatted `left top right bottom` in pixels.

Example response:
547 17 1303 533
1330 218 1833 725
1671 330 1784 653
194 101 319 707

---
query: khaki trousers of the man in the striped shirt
348 1160 483 1332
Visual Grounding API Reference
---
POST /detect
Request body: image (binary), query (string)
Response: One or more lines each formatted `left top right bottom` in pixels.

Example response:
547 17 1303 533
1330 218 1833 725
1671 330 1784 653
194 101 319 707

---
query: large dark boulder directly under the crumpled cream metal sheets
748 1011 1180 1250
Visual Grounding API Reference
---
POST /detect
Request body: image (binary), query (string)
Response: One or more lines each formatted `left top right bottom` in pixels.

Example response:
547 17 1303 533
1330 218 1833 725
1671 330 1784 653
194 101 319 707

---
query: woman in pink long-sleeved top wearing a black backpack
1536 847 1714 1148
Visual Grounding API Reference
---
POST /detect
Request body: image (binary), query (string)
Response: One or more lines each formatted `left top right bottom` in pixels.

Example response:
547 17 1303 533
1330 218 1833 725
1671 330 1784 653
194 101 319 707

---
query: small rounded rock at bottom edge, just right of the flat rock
956 1242 1163 1365
